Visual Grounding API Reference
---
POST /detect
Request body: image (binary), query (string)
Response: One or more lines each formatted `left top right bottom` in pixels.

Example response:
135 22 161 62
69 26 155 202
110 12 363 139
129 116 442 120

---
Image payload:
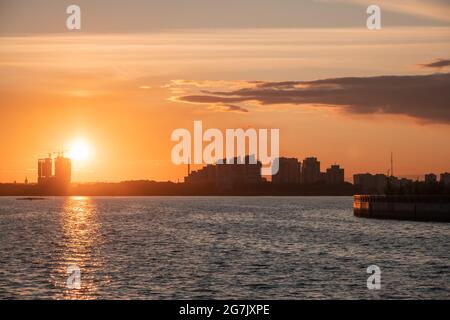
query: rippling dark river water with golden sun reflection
0 197 450 299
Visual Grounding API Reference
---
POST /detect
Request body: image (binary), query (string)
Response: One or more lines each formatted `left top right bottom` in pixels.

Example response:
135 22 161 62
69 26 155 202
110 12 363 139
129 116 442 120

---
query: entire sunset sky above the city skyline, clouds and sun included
0 0 450 182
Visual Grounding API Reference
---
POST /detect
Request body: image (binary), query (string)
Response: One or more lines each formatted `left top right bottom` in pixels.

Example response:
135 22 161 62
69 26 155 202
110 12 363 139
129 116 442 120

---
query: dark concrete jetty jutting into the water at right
353 195 450 222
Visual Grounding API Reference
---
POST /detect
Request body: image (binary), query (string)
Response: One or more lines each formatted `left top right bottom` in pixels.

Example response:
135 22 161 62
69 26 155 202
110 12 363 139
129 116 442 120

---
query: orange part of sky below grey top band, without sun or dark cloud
0 27 450 182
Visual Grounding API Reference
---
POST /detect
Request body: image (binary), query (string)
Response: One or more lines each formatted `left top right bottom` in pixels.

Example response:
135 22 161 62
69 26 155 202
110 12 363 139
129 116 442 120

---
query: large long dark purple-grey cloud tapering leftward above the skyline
173 73 450 124
